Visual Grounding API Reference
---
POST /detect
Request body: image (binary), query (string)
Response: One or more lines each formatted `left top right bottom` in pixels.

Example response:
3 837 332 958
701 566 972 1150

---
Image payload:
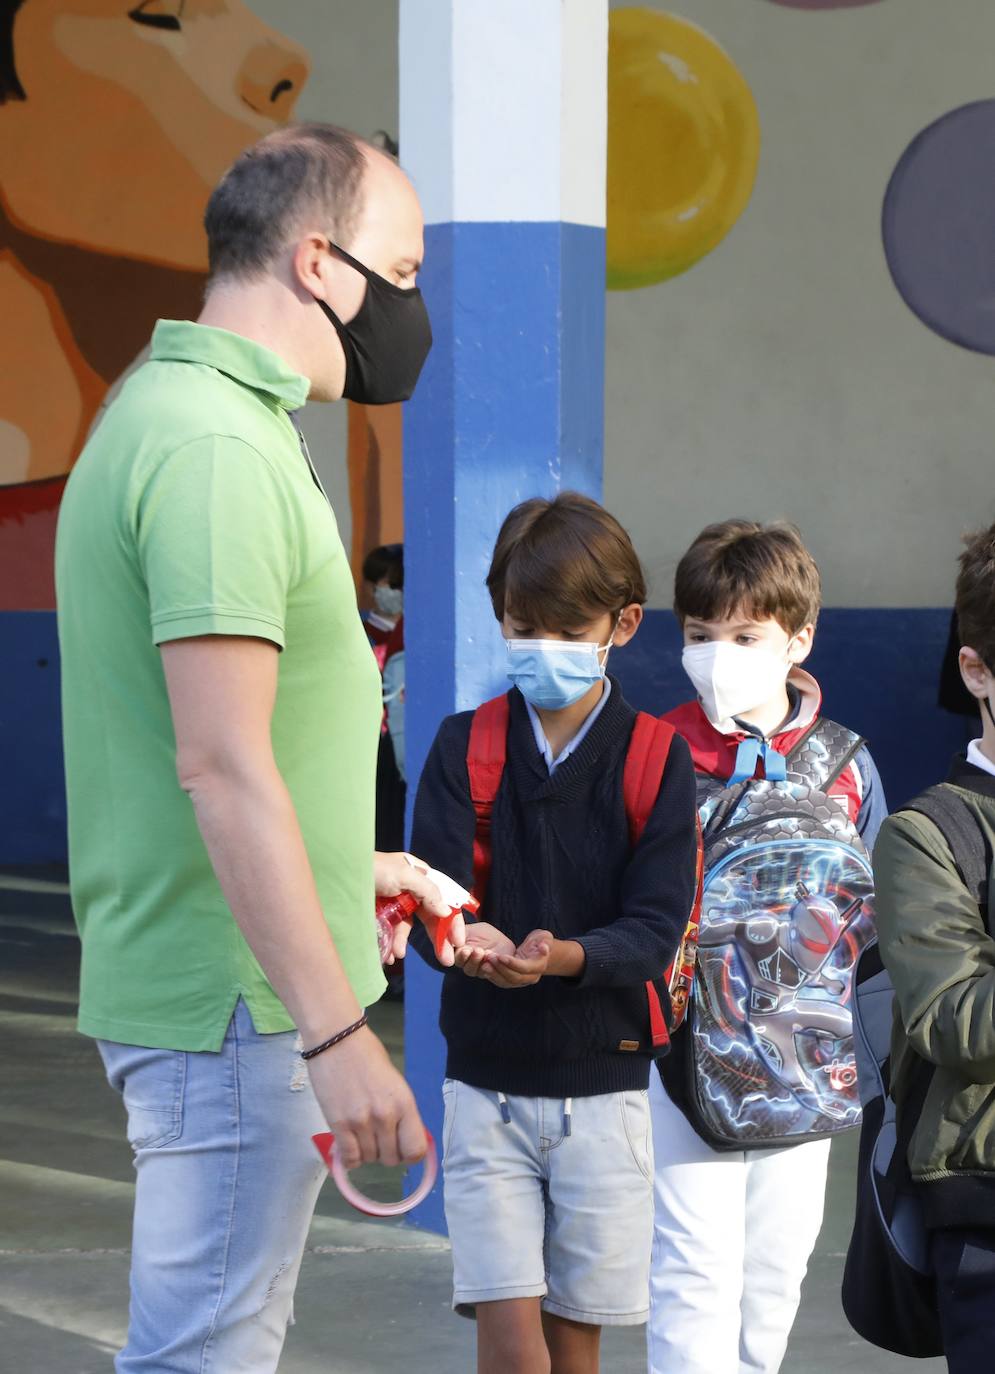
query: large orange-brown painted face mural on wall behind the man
0 0 308 610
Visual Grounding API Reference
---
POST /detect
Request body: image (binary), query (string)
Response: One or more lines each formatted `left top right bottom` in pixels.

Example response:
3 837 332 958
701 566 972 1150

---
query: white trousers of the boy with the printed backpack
647 1070 830 1374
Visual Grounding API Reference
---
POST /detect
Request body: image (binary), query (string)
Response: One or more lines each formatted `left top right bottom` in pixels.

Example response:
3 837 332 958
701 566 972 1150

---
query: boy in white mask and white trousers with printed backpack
649 519 886 1374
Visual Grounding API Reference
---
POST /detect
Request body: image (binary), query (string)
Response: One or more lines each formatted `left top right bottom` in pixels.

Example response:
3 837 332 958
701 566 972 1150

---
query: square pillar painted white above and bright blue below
400 0 607 1230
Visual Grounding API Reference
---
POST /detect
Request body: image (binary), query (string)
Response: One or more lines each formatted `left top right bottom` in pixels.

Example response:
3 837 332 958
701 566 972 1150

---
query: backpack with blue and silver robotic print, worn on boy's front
686 720 874 1150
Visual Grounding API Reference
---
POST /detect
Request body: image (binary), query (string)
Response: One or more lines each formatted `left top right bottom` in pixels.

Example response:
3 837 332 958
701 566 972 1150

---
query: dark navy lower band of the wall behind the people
0 609 962 864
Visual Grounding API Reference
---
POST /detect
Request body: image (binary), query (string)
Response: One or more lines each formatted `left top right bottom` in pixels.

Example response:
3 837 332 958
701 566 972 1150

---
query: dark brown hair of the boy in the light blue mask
487 492 646 629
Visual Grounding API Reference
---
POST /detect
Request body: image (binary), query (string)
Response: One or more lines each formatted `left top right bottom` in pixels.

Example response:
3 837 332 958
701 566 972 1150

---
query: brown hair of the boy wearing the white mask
673 519 822 635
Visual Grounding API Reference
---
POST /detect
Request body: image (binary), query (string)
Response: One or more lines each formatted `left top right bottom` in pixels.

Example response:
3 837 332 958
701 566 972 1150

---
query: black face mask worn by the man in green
317 239 432 405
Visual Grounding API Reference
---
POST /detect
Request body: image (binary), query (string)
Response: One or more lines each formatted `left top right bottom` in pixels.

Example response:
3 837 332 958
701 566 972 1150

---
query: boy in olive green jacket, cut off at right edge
874 525 995 1374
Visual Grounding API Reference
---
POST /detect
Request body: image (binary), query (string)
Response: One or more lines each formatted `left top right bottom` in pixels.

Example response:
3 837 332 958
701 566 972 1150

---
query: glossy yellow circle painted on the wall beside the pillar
607 7 760 291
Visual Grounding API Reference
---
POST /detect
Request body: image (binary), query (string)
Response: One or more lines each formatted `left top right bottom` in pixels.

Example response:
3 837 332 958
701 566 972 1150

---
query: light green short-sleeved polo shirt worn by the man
56 320 383 1050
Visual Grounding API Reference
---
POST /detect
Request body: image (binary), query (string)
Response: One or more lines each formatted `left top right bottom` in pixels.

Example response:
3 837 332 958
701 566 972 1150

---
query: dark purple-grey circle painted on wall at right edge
881 100 995 354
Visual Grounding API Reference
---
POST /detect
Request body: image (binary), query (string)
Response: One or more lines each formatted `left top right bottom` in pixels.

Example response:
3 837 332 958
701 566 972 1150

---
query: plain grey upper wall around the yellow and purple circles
606 0 995 606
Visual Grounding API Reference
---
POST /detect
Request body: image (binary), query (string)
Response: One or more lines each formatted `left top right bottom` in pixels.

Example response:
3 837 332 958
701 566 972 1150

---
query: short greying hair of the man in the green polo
203 124 367 282
